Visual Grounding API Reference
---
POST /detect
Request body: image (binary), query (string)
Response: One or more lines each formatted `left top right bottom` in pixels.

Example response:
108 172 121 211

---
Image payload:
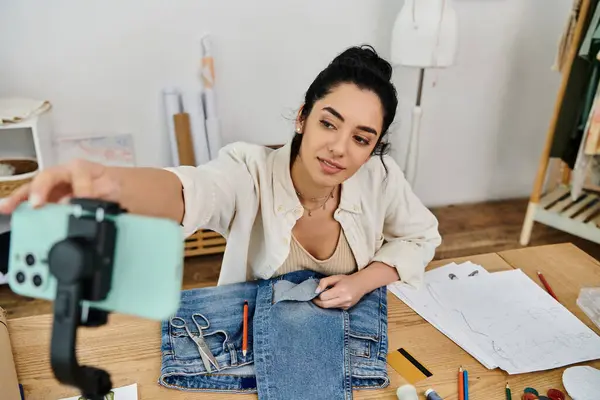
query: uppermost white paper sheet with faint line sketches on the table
430 270 600 374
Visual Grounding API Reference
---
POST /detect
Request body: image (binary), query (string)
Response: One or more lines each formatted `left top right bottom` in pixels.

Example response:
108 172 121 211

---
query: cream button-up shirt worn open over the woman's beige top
166 142 441 287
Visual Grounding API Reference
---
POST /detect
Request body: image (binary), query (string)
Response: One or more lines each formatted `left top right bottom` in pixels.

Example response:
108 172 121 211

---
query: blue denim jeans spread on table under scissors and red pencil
159 271 389 400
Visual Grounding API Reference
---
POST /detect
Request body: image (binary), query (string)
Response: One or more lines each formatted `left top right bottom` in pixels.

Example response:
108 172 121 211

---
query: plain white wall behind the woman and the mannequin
0 0 571 205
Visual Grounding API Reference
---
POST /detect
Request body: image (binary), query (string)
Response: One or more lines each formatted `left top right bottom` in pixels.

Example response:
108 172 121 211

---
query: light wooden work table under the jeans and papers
9 244 600 400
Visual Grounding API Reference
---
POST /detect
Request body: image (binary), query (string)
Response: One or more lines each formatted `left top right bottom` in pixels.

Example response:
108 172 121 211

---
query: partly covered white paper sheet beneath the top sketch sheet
388 262 497 369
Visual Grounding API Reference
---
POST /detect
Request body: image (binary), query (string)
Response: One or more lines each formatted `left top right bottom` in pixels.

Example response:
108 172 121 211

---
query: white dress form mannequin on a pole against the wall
392 0 458 184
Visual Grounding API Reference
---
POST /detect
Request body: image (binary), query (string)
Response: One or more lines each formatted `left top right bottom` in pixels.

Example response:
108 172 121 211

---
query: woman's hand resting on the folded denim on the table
313 273 366 310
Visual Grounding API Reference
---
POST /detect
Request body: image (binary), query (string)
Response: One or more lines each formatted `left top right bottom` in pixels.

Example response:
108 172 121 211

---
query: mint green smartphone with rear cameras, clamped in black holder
8 203 184 320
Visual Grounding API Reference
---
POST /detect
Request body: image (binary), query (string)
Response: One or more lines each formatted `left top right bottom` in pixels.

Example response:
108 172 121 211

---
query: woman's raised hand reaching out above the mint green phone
0 160 121 214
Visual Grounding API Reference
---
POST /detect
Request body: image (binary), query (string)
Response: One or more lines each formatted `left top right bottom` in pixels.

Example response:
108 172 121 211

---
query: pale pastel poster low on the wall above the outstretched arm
56 134 136 167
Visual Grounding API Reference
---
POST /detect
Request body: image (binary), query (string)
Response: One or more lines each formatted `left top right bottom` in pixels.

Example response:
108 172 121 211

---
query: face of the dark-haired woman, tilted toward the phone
296 83 383 187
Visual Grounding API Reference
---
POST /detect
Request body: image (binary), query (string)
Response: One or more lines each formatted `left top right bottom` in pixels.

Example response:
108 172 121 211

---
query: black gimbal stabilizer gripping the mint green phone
48 199 124 400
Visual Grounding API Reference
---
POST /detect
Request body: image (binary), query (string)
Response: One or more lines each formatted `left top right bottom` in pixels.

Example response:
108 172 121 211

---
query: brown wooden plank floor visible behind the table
0 199 600 318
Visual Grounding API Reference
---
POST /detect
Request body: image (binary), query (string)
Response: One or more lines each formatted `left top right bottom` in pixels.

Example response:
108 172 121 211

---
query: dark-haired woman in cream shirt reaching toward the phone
0 47 441 309
